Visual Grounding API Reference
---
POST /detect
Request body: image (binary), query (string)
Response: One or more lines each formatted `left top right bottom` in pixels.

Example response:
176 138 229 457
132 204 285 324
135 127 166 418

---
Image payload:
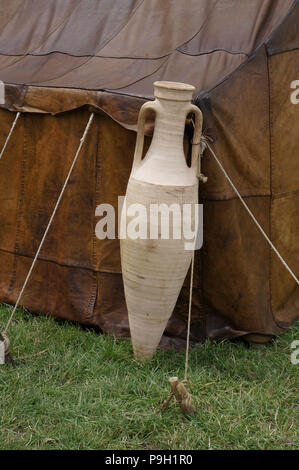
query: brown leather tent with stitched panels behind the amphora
0 0 299 346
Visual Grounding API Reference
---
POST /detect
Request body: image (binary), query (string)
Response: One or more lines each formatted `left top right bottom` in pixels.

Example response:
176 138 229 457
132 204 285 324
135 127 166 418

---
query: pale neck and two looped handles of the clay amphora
131 82 201 186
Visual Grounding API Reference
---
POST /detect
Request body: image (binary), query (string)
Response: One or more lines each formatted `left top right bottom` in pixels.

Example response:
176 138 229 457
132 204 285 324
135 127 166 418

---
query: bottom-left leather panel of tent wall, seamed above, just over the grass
0 251 96 323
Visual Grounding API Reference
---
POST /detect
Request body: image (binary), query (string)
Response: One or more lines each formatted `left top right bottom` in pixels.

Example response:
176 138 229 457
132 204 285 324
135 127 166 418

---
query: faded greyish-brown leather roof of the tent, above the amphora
0 0 294 113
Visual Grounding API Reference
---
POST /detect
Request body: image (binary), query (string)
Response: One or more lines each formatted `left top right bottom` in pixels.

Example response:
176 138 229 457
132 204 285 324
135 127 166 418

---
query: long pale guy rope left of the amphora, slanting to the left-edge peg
0 113 94 364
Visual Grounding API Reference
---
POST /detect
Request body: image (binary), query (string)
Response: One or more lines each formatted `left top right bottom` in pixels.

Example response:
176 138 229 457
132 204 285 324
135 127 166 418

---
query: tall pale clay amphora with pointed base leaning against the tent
120 82 202 360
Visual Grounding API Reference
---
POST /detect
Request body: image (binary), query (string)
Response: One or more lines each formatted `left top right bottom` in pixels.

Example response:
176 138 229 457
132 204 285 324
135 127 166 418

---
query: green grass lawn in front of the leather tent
0 306 299 450
